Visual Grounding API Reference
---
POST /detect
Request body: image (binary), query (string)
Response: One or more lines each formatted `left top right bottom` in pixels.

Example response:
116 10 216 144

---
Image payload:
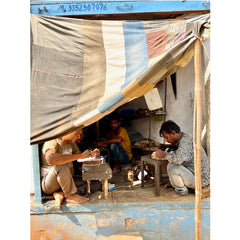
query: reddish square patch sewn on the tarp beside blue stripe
147 30 167 59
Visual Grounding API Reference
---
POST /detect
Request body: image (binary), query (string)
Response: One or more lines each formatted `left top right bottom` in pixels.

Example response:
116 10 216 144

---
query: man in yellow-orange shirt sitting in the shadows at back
97 114 132 174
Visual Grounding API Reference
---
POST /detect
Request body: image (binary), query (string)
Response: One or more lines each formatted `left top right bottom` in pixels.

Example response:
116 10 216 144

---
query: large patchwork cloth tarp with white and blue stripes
31 14 210 144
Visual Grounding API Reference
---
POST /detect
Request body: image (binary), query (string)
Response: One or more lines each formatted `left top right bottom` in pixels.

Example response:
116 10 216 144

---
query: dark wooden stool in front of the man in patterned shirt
141 155 168 196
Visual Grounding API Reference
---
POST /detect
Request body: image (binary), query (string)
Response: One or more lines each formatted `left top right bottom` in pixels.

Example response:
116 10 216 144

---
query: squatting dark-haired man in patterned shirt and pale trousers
156 121 210 197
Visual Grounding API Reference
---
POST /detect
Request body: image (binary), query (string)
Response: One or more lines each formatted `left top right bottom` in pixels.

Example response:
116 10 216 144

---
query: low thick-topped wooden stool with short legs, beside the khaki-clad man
82 163 112 199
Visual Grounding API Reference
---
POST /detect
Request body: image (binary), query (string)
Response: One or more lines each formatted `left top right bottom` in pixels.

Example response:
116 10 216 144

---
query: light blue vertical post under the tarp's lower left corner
32 144 42 203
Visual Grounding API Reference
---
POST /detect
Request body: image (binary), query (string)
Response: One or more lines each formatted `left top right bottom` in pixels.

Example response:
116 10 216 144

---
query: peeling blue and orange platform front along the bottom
31 201 210 240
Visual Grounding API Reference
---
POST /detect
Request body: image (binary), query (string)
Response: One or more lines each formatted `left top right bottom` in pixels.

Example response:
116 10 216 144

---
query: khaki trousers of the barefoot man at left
42 163 77 194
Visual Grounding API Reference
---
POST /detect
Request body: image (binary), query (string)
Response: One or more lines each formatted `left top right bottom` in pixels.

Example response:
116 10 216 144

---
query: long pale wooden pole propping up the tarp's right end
194 39 202 240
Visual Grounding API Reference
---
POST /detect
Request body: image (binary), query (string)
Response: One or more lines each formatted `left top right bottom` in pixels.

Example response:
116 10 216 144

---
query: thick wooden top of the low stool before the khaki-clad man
82 163 112 181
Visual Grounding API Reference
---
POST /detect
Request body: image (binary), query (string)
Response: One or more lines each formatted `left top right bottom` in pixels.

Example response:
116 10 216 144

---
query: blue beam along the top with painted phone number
30 0 210 16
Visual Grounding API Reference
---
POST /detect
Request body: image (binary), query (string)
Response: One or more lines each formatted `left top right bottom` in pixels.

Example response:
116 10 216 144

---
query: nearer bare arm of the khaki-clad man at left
45 149 91 166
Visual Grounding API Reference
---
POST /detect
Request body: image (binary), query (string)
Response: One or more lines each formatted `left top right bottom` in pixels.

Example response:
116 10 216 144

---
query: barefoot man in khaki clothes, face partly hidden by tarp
41 129 100 209
